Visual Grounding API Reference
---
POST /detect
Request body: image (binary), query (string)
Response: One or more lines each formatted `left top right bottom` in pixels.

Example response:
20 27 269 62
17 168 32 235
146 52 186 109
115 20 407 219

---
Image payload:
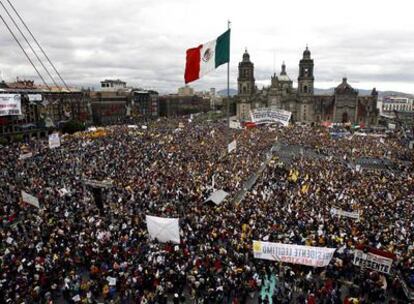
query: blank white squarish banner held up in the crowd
145 215 180 243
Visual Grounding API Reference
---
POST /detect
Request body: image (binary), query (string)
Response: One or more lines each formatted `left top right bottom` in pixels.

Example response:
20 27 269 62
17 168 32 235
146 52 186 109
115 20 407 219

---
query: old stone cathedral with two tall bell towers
236 47 379 126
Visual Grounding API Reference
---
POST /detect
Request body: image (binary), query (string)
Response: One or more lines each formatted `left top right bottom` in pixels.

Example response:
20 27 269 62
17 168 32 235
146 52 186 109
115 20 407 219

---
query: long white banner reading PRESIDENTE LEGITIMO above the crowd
253 241 336 267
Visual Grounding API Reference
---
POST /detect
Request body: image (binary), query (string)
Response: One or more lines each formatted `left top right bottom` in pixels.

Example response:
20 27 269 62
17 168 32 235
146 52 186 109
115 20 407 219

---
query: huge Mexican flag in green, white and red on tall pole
184 29 230 83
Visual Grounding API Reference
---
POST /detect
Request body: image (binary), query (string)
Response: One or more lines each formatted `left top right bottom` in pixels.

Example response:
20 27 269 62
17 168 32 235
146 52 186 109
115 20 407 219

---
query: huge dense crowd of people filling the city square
0 119 414 304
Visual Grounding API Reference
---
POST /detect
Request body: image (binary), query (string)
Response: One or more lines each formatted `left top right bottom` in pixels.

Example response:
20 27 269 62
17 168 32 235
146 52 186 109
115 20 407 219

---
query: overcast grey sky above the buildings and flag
0 0 414 93
